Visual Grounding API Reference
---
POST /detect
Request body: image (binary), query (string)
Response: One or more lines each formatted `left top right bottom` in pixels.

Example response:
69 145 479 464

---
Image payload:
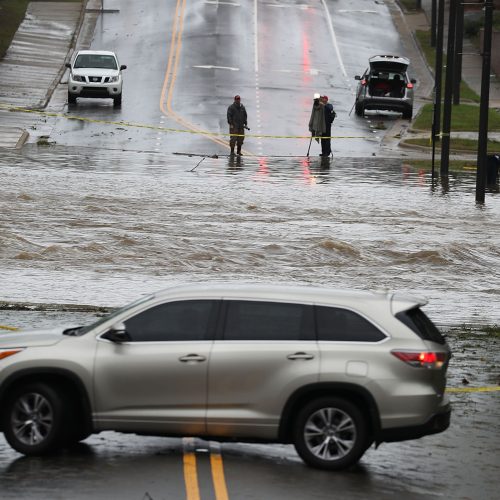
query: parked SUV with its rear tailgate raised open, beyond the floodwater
354 55 416 120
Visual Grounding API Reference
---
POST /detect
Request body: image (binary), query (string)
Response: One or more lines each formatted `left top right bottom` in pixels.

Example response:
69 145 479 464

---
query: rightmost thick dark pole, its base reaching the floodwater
476 0 493 203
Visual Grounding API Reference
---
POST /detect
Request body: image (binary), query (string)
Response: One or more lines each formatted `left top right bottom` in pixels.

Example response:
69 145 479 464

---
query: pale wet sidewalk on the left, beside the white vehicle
0 0 100 148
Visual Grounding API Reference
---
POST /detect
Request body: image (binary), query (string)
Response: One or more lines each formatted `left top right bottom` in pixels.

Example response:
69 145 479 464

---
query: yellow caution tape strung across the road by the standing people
0 103 371 139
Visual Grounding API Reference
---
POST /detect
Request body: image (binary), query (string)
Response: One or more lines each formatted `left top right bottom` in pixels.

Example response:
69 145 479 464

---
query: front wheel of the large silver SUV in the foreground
2 383 65 455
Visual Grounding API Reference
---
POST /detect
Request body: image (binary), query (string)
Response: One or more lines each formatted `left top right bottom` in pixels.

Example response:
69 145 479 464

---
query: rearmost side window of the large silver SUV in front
316 306 386 342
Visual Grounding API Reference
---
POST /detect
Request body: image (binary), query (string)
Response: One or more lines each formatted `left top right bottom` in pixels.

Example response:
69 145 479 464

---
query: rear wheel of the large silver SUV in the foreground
294 398 368 470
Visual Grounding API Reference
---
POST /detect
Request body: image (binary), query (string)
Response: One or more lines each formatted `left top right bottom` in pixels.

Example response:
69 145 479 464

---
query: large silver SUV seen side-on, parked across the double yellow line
0 284 450 470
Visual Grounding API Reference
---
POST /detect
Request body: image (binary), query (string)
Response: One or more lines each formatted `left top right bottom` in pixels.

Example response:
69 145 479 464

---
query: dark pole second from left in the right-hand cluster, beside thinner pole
440 0 458 175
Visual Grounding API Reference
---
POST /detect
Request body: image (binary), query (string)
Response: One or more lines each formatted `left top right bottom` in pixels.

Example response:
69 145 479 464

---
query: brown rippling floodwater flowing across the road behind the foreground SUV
0 145 500 325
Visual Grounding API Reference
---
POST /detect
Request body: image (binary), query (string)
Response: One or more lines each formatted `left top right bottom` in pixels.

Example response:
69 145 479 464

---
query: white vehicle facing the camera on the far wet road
66 50 127 106
